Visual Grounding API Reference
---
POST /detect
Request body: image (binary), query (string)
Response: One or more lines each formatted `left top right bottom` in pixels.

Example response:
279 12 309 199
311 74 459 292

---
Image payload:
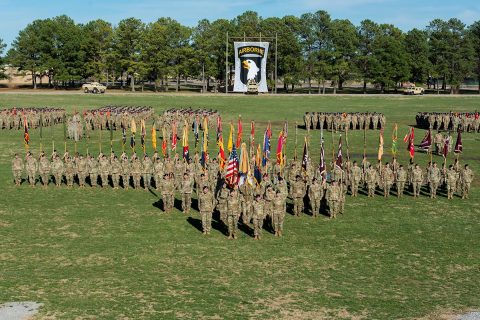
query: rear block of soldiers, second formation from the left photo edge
83 106 155 131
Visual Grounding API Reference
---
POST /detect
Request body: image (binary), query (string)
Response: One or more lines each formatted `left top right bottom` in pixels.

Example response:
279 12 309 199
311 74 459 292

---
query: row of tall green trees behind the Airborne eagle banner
0 11 480 93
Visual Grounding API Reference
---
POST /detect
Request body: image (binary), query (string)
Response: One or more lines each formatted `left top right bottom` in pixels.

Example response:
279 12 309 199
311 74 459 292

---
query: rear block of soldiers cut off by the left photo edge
0 107 65 130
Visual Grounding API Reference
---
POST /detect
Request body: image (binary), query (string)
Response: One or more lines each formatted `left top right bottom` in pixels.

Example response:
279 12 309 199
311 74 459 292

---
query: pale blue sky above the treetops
0 0 480 45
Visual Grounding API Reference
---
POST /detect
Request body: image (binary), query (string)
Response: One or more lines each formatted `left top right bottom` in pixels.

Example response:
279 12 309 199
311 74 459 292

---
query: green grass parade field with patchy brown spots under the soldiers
0 94 480 319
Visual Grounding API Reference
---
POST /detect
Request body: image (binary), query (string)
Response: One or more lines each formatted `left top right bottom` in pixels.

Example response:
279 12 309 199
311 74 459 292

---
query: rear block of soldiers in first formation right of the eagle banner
303 112 387 132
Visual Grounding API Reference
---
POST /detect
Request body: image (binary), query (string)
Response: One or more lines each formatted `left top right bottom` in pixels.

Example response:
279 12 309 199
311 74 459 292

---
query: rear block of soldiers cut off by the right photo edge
415 111 480 132
